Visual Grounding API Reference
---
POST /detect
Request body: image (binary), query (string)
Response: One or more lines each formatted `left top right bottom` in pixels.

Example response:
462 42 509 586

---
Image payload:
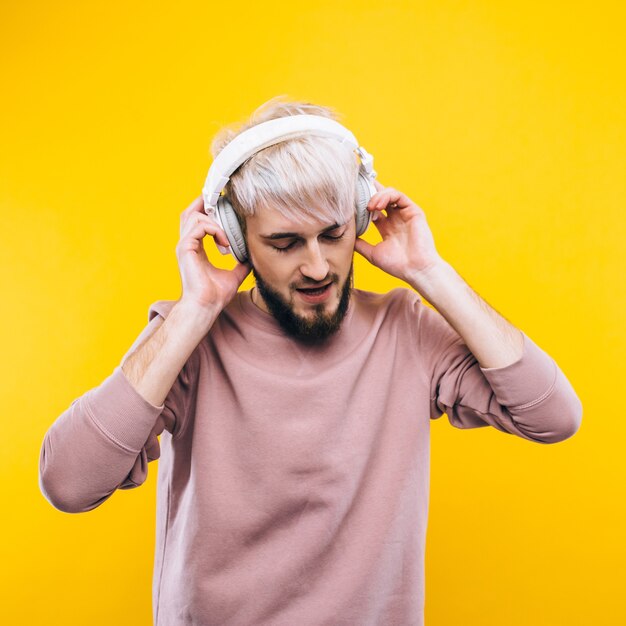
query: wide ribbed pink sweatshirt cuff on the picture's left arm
85 365 165 453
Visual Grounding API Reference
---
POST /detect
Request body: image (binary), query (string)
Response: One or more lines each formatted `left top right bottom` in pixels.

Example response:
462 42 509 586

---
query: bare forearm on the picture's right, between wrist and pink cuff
408 260 524 368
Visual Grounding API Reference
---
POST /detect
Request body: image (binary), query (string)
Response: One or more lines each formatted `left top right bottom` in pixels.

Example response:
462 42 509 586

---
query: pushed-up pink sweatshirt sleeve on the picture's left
39 305 197 513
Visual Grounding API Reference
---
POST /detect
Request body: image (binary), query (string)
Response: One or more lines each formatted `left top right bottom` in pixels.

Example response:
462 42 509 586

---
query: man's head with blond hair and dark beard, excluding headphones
212 97 359 343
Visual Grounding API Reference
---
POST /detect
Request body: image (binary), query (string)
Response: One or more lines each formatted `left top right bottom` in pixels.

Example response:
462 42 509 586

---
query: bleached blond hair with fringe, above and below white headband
211 95 359 234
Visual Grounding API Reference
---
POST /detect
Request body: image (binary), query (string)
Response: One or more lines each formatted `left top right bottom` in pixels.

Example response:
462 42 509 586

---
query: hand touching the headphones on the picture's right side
354 180 443 284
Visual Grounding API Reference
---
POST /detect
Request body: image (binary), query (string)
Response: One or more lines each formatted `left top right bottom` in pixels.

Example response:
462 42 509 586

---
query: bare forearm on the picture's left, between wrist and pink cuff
122 302 219 406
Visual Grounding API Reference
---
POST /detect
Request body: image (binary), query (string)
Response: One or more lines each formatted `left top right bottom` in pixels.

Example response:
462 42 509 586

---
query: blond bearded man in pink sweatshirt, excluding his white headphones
40 95 582 626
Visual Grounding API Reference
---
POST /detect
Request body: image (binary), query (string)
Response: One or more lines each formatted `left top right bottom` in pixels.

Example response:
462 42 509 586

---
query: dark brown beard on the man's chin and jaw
251 262 354 345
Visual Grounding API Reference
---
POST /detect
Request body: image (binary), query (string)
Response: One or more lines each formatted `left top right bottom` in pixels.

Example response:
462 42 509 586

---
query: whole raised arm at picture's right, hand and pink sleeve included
355 181 582 443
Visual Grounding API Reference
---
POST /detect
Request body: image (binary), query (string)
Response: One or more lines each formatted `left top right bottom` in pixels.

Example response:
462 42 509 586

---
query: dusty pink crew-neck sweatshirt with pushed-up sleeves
39 288 582 626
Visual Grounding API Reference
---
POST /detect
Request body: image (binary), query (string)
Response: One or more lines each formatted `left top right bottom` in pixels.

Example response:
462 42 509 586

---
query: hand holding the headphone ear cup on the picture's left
176 196 250 313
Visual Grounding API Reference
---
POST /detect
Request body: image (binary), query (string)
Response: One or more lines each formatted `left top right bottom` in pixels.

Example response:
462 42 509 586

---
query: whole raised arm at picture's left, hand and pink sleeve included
39 198 249 513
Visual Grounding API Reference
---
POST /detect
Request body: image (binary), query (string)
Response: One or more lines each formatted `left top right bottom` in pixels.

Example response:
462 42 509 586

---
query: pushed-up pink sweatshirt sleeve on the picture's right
413 292 582 443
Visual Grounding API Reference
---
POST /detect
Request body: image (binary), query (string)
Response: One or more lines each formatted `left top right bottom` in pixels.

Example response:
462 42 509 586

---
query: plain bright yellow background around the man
0 0 626 626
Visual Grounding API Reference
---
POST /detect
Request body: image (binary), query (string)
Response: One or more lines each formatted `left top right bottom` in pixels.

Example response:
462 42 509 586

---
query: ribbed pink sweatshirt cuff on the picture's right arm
480 331 558 409
